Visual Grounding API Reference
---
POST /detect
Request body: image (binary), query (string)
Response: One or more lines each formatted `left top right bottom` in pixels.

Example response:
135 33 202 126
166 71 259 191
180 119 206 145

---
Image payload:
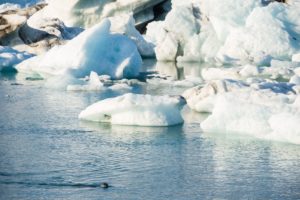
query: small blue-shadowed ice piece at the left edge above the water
0 46 33 71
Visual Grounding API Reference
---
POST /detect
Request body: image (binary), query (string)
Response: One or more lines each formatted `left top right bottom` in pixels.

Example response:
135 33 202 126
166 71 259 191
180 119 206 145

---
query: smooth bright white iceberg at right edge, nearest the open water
201 90 300 144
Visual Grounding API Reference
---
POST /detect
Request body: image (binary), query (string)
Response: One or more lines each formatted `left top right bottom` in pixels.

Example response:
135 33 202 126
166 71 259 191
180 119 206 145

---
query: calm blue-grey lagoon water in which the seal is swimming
0 61 300 200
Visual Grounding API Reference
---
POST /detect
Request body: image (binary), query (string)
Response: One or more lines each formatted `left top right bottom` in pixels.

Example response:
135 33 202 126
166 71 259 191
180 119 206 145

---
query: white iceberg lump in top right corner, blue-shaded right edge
219 2 300 60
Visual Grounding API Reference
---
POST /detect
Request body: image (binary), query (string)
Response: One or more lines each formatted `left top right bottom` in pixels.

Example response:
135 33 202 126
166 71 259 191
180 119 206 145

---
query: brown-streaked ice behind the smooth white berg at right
182 78 298 113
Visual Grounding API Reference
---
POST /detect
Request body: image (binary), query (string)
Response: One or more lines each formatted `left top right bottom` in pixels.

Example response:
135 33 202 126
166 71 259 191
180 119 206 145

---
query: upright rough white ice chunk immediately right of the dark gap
146 4 200 61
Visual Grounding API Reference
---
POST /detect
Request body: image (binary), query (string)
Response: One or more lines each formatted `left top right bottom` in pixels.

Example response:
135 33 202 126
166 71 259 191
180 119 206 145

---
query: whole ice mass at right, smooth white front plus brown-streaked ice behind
183 80 300 144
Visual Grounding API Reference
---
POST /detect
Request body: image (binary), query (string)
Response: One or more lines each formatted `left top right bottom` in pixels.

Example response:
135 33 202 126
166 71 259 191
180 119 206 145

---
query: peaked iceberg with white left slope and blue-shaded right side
16 19 142 79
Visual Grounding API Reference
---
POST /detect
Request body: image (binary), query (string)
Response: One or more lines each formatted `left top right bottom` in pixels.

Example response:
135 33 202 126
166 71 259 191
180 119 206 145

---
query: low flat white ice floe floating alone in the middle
79 93 185 126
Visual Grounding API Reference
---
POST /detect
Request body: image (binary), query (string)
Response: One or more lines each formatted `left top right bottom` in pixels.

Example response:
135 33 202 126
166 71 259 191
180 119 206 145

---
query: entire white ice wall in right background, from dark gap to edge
146 0 300 65
